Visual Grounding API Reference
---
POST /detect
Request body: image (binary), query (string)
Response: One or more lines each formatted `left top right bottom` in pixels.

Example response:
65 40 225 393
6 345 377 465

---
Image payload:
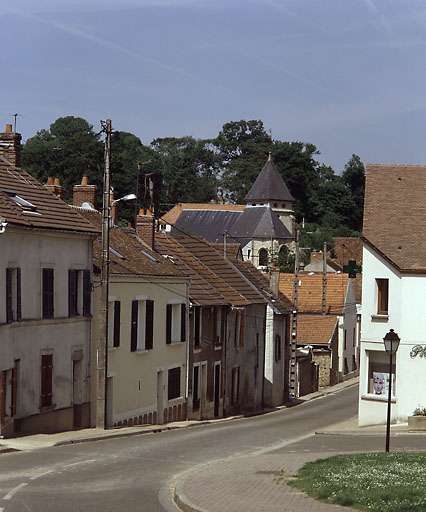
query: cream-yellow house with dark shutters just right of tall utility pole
78 208 189 426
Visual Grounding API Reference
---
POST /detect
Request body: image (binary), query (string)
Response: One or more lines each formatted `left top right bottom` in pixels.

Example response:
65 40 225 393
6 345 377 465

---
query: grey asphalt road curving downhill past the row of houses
0 386 358 512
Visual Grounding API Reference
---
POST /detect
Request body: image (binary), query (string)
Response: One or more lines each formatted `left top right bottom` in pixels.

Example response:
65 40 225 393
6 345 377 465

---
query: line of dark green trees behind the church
22 116 365 248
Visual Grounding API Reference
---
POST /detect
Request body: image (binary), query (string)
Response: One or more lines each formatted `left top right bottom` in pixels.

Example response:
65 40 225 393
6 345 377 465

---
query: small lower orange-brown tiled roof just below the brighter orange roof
296 315 338 346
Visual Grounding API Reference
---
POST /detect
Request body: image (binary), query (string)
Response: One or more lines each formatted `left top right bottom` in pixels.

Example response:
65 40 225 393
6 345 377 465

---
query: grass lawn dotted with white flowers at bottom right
281 453 426 512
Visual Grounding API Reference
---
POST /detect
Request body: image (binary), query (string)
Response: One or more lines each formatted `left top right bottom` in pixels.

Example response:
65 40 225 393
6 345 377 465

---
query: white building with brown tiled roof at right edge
359 165 426 425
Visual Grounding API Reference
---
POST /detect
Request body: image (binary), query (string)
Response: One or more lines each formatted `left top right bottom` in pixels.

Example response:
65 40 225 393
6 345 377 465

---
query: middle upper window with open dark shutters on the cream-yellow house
130 300 154 352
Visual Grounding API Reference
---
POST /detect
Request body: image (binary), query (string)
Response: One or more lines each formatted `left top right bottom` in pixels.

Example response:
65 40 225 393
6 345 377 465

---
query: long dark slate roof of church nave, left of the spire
171 209 243 243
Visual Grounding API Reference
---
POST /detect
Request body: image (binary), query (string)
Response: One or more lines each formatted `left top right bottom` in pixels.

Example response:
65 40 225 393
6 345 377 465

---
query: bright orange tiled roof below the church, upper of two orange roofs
279 274 353 315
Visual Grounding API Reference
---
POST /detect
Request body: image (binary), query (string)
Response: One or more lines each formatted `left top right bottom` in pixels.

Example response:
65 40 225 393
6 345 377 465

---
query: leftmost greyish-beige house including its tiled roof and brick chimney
0 125 97 435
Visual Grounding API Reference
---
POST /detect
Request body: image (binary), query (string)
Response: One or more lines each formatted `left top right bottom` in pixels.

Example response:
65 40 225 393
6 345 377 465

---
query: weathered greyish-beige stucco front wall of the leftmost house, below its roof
0 230 92 433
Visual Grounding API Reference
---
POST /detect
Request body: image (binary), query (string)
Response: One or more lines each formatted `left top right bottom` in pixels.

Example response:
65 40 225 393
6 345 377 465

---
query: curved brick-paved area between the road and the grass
176 453 355 512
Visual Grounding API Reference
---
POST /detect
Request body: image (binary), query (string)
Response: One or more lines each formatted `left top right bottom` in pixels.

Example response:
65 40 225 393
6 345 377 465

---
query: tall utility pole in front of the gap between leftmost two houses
96 119 112 429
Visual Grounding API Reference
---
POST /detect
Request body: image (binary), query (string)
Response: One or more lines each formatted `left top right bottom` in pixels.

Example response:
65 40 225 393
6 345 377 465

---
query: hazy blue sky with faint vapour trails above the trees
0 0 426 173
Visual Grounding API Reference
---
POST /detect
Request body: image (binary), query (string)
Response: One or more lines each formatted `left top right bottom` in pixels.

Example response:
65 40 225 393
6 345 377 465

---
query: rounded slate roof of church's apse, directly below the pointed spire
229 206 293 246
